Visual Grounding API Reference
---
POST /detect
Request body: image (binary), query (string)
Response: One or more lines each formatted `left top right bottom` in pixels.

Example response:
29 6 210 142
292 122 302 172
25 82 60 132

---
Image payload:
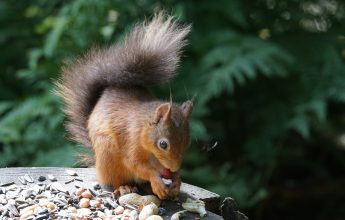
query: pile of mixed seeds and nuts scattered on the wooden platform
0 171 176 220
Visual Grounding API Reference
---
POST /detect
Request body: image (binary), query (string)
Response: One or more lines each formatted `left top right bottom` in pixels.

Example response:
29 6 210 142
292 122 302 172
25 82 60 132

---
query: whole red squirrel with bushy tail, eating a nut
57 13 193 199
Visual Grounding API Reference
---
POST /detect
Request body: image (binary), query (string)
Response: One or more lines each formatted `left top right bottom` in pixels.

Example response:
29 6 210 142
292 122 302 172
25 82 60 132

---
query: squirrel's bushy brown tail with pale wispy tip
56 12 190 147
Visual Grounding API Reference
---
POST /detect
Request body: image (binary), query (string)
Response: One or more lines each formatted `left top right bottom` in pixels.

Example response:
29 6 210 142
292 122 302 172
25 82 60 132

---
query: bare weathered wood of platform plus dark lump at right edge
0 167 248 220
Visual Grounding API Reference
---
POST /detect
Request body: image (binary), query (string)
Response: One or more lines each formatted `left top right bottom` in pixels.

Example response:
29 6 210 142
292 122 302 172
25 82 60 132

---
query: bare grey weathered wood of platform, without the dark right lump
0 167 223 220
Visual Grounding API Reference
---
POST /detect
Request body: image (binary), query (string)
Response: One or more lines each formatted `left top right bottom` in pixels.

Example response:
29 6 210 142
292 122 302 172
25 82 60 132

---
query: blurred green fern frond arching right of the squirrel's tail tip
200 36 293 103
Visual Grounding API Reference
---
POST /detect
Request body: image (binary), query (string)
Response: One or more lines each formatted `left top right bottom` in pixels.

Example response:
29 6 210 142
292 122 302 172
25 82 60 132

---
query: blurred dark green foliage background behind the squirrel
0 0 345 219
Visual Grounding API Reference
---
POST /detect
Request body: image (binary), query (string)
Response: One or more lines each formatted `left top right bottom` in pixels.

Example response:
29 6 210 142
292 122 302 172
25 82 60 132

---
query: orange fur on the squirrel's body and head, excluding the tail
88 88 189 198
